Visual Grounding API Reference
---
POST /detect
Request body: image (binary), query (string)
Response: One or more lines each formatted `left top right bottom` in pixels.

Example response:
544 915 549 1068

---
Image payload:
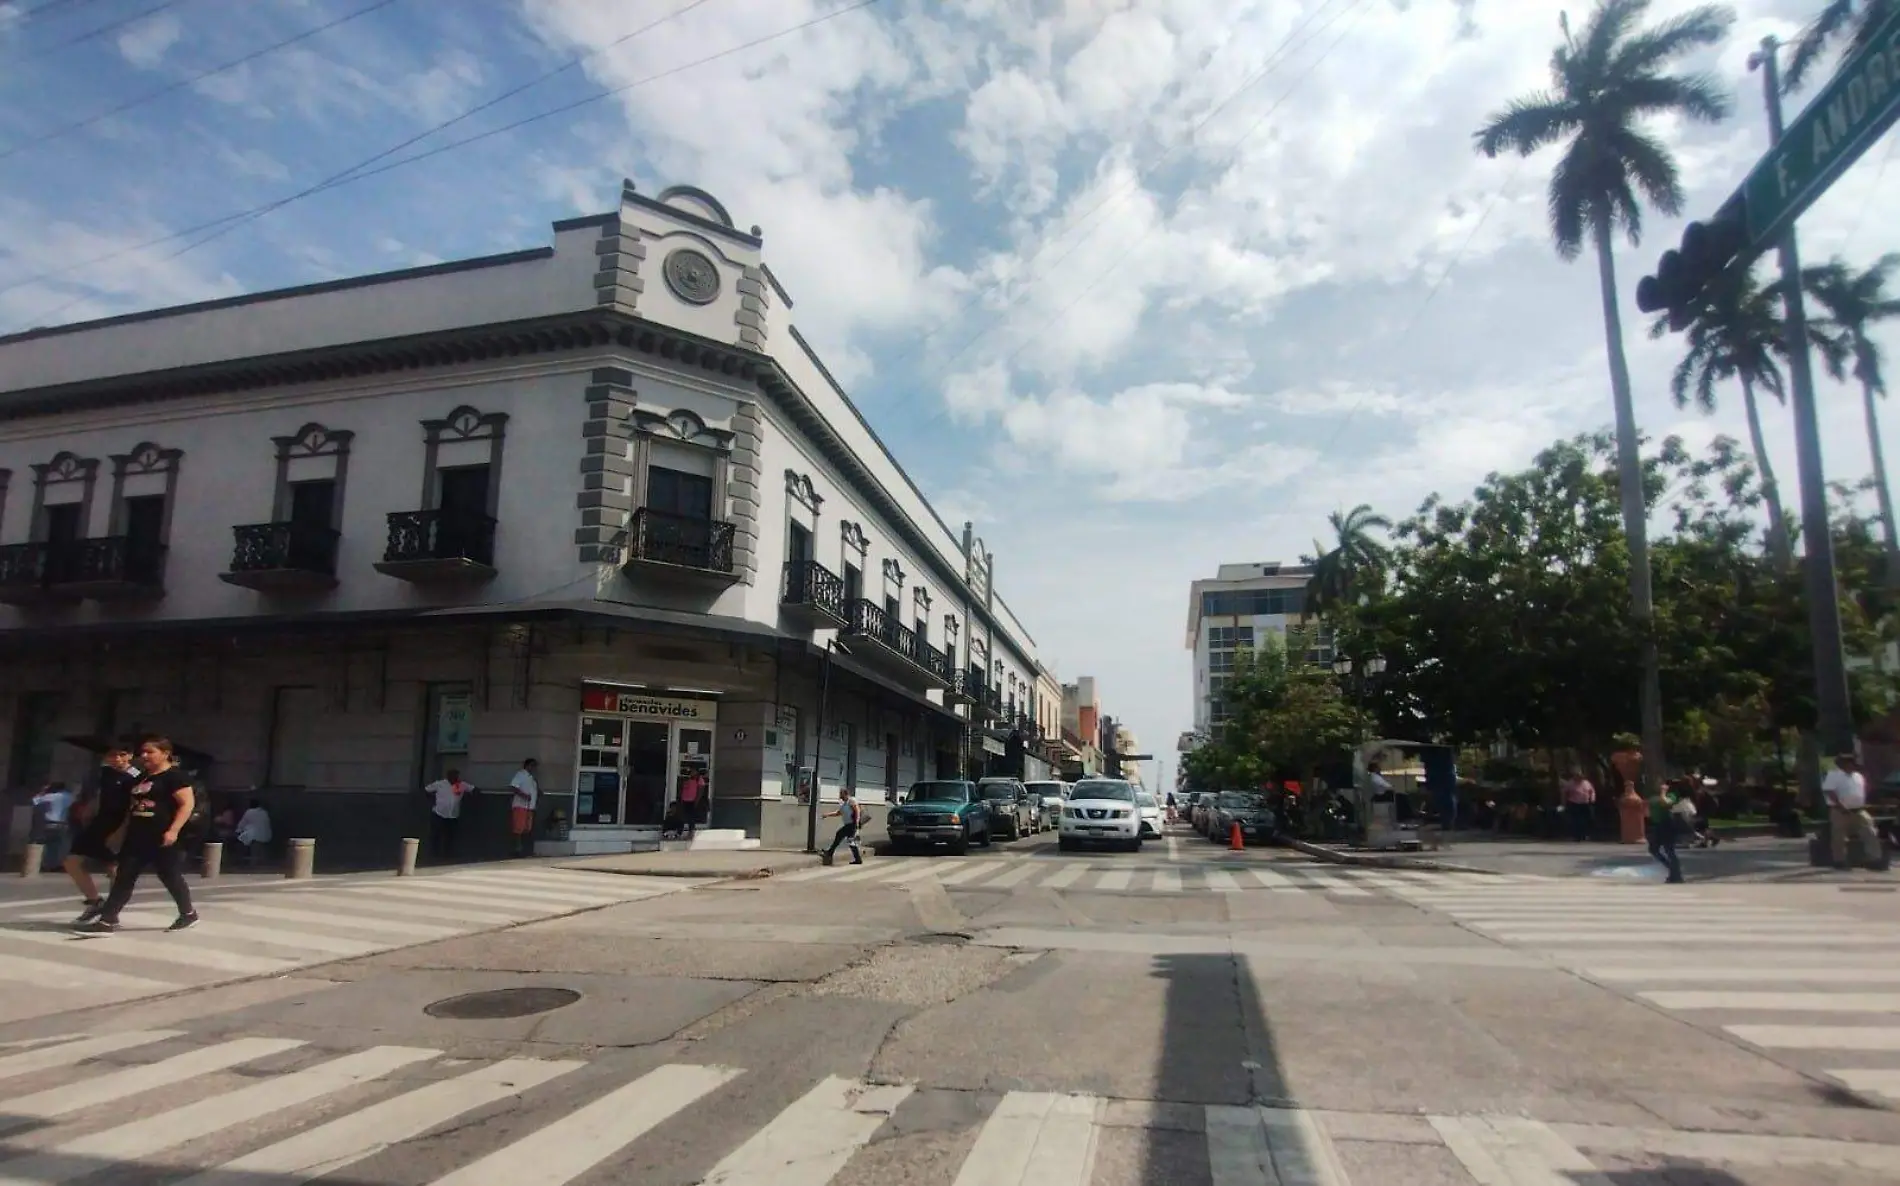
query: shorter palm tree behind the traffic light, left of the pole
1649 270 1794 572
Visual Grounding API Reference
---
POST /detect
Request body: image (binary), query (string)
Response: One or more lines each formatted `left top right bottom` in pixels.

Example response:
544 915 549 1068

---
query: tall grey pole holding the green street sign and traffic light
1748 36 1854 755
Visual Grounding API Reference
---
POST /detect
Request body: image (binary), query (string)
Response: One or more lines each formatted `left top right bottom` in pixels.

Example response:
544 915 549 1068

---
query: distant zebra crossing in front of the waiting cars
773 857 1552 897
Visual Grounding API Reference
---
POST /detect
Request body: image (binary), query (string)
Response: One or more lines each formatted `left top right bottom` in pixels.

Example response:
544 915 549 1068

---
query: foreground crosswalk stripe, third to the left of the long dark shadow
431 1062 745 1186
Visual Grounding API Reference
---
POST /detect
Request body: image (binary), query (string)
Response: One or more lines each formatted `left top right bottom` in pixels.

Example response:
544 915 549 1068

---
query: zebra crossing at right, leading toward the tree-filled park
1395 880 1900 1100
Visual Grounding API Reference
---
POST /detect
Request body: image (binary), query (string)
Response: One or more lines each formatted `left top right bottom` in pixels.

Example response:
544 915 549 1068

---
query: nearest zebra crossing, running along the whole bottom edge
0 1030 1900 1186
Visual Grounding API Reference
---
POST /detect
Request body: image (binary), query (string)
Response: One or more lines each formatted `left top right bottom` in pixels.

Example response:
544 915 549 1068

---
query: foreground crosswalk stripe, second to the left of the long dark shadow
705 1076 912 1186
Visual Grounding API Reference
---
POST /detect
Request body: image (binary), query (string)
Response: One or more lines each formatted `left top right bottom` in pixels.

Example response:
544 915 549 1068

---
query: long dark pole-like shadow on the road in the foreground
1140 954 1299 1182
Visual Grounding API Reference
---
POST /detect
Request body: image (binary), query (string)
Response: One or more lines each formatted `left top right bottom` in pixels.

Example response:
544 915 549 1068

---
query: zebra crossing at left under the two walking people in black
0 867 699 1021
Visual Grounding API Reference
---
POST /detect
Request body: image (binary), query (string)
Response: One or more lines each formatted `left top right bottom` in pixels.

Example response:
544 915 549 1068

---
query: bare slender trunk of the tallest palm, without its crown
1592 211 1663 794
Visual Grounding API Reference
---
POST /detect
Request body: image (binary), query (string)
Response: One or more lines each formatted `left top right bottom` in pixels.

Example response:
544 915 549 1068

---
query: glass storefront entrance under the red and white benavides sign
574 686 718 827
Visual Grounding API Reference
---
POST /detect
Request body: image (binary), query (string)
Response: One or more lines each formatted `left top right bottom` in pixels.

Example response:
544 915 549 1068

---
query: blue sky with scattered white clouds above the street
0 0 1900 786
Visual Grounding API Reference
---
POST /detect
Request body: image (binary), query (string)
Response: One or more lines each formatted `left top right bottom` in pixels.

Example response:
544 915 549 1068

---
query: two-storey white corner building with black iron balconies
0 182 1047 865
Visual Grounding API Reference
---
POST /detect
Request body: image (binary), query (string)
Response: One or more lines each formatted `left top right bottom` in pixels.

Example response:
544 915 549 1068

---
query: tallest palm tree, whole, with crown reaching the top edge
1476 0 1735 798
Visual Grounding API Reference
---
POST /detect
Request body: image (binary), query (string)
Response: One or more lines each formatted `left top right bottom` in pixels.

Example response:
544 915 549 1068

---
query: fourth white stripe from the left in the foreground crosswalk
175 1059 585 1186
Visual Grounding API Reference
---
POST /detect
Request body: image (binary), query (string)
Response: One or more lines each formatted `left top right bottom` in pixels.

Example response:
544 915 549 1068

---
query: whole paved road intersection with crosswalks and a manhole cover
0 838 1900 1186
